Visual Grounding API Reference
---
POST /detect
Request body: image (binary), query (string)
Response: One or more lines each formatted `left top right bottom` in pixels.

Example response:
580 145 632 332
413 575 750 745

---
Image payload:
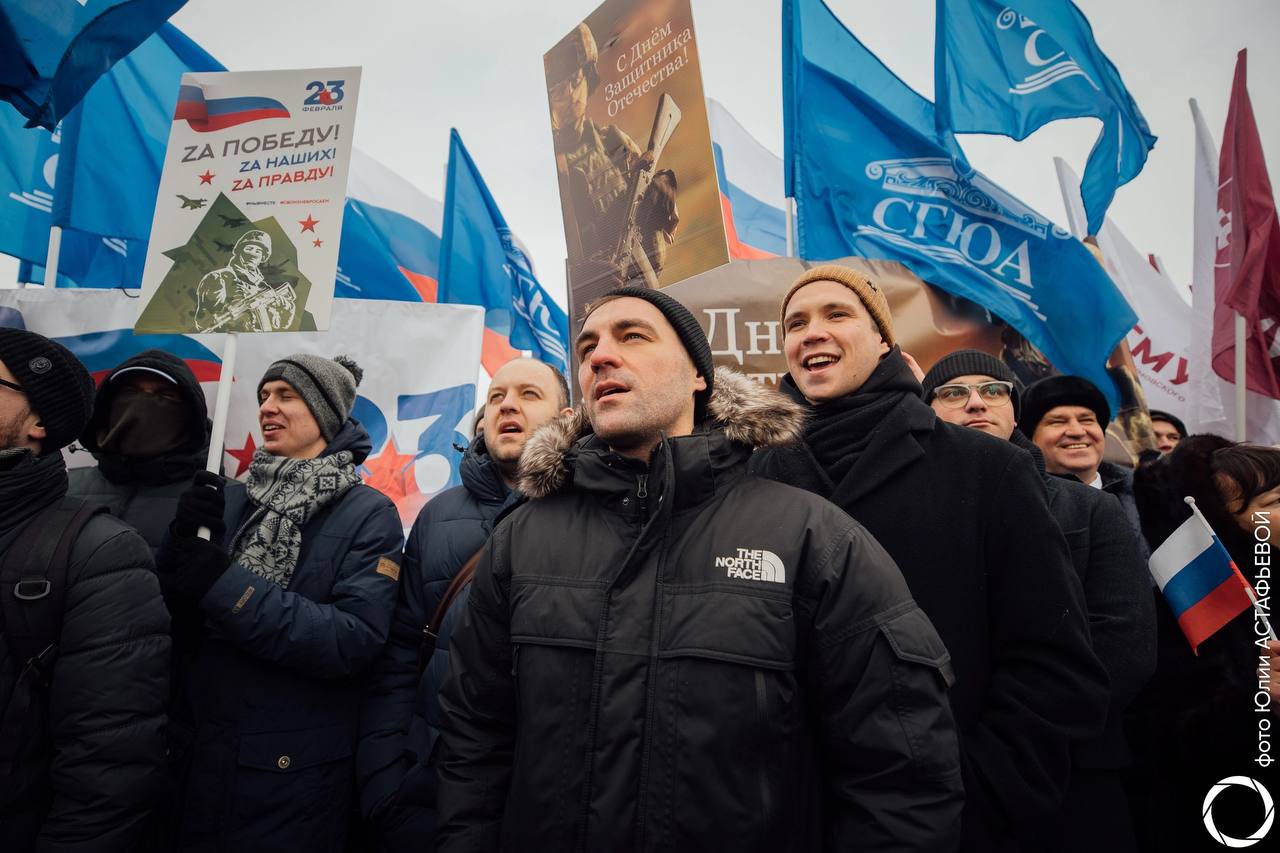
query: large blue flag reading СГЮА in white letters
782 0 1137 407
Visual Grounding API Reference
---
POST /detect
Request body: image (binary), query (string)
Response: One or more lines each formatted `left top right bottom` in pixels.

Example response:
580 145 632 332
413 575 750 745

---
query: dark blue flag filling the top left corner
0 0 187 129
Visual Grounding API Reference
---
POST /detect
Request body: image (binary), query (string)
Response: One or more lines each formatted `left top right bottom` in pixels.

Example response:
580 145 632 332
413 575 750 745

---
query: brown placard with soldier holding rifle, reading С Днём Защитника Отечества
543 0 728 316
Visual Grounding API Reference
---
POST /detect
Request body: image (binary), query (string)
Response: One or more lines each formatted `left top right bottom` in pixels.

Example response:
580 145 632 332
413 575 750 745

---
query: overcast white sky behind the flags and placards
0 0 1280 301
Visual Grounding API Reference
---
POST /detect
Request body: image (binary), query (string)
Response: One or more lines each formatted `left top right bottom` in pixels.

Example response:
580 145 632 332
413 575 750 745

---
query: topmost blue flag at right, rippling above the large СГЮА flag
934 0 1156 234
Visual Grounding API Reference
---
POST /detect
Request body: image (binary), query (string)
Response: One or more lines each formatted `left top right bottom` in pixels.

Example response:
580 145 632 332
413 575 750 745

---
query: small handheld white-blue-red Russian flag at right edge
1149 512 1253 654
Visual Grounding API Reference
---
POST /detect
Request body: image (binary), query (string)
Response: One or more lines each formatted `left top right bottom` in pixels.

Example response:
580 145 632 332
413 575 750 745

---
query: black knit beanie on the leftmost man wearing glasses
0 327 93 455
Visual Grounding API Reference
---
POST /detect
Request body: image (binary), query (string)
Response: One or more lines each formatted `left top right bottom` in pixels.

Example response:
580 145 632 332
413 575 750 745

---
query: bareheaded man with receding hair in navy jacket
358 359 572 852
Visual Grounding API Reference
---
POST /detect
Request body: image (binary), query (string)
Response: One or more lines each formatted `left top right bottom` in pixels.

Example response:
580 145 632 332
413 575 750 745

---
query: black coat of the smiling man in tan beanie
753 377 1108 853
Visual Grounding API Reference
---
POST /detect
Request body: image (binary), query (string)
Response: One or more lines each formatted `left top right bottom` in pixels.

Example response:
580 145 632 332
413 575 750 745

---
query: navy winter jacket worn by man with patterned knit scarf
163 420 403 853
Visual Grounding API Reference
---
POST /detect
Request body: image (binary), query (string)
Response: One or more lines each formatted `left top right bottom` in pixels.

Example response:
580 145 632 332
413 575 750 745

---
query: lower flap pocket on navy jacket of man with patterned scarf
234 725 355 850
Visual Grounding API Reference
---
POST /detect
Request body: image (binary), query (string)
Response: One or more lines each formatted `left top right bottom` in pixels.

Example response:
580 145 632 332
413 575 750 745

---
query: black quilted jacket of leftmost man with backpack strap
0 456 169 853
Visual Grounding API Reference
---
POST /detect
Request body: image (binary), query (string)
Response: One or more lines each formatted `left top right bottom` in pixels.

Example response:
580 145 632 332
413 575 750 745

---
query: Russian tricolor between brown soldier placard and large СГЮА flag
707 99 787 260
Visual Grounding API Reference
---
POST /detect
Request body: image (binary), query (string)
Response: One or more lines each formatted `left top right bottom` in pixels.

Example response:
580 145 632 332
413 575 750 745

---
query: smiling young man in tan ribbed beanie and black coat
755 264 1107 853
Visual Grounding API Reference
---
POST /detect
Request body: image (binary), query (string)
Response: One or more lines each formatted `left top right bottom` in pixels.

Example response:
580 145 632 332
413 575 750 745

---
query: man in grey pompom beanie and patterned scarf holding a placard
156 355 402 853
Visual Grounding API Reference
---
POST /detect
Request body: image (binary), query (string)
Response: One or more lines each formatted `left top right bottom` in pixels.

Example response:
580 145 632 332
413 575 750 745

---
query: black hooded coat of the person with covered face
68 350 210 549
